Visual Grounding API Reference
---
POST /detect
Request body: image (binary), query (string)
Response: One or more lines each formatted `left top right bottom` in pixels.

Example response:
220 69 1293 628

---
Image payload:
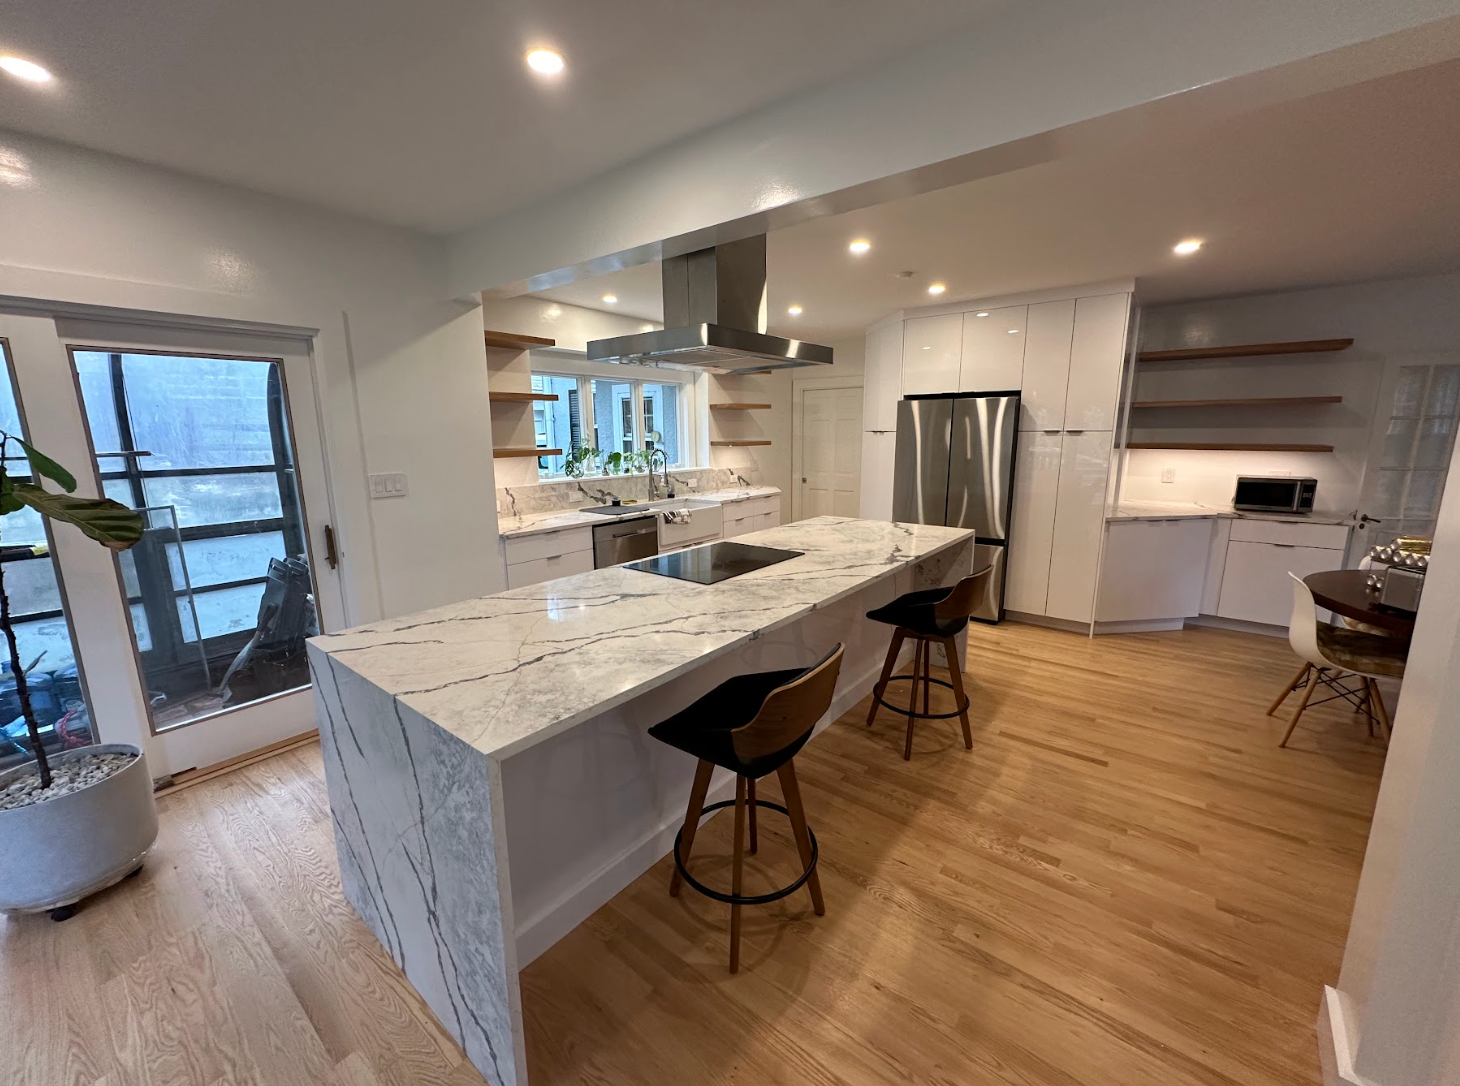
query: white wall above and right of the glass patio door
0 133 501 622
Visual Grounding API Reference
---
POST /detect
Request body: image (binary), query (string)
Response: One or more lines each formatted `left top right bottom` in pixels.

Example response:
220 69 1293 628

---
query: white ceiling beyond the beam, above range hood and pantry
545 61 1460 342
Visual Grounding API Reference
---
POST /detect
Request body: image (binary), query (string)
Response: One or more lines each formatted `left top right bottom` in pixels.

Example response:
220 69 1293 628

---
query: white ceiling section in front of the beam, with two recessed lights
0 0 1012 232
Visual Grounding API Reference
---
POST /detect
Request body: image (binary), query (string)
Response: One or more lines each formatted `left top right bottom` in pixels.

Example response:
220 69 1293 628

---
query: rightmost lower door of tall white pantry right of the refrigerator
1044 431 1114 622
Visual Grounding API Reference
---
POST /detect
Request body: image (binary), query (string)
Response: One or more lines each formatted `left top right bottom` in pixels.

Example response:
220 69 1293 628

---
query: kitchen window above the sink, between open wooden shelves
533 356 701 477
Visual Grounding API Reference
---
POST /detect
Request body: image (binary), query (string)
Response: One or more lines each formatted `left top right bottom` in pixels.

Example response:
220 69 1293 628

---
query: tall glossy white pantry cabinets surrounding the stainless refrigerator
861 283 1133 623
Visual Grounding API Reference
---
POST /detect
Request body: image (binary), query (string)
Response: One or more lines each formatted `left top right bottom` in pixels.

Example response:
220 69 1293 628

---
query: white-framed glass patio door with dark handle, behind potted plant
0 317 343 777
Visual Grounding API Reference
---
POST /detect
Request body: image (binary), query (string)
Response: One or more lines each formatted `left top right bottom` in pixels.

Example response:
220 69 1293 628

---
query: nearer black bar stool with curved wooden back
648 644 842 972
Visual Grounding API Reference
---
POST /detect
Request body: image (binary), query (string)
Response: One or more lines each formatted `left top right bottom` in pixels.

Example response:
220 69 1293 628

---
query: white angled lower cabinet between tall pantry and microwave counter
1095 517 1213 622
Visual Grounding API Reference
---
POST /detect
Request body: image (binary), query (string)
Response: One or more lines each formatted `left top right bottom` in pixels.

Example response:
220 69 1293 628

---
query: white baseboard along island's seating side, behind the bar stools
517 653 882 969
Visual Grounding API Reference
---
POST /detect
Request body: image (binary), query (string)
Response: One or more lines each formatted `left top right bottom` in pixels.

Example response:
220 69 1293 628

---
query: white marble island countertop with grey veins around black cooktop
310 517 974 758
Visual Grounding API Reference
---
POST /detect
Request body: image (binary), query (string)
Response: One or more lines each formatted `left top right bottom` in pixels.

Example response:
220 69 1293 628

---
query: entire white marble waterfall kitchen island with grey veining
310 517 974 1086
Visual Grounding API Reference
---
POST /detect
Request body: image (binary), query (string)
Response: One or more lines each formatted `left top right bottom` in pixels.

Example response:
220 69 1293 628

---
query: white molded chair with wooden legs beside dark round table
1267 572 1409 746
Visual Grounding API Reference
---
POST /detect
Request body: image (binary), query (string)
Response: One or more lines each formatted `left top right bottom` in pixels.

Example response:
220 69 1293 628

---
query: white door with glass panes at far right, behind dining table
1349 355 1460 565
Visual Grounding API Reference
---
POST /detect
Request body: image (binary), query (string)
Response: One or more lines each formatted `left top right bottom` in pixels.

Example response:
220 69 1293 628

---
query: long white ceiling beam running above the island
448 0 1460 296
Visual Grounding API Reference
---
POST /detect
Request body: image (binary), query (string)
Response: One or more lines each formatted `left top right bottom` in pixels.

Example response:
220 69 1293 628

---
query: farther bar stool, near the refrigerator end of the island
867 565 994 762
